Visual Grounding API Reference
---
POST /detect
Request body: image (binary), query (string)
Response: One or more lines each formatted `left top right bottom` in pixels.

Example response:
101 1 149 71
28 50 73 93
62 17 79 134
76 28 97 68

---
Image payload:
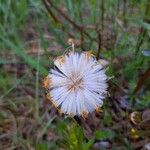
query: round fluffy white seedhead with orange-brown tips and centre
44 52 107 116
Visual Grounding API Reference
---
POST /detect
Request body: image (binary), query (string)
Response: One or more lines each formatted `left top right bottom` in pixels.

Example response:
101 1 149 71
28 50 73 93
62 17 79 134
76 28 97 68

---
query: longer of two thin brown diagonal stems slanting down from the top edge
47 0 96 41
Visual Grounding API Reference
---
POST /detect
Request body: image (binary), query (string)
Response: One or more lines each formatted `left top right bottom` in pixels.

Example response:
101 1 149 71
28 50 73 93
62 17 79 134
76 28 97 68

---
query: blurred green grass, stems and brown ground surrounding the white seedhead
0 0 150 150
